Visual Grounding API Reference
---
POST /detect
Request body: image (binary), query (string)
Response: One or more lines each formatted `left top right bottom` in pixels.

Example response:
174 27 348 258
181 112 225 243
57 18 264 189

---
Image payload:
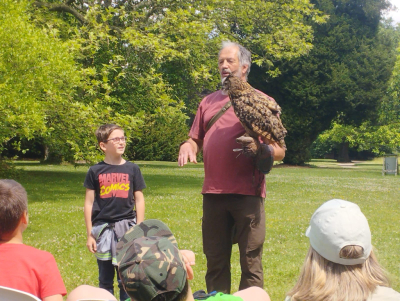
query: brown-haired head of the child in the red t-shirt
0 180 28 239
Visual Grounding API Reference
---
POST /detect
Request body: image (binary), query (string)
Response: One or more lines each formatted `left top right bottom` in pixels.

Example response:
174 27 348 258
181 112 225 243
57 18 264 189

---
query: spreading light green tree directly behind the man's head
27 0 324 159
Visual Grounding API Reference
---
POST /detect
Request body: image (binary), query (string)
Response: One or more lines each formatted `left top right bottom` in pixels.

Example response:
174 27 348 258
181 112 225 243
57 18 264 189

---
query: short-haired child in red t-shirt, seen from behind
0 180 67 301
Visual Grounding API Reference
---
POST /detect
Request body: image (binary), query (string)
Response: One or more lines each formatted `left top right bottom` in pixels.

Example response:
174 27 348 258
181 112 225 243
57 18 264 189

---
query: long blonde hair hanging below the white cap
287 246 389 301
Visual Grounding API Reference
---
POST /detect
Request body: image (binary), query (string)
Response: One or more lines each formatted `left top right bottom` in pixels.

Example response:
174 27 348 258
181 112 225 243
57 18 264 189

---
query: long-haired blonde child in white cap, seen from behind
285 199 400 301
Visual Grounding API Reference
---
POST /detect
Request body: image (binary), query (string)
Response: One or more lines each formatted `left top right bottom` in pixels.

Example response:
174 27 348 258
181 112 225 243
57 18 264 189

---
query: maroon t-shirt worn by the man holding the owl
189 91 265 198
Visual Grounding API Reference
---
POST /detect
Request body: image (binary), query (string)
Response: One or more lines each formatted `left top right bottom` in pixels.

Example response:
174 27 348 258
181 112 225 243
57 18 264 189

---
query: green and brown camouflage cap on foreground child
117 219 186 301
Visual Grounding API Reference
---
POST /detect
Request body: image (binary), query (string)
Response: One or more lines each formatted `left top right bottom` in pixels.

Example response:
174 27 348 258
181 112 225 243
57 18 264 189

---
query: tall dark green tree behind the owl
253 0 394 164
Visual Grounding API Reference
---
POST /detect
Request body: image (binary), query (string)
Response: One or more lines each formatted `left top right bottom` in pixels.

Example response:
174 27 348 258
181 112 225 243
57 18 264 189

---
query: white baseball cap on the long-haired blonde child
306 199 372 265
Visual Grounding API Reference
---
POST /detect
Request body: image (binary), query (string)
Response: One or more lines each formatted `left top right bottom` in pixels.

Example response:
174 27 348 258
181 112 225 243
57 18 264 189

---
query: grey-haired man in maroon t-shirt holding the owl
178 42 285 293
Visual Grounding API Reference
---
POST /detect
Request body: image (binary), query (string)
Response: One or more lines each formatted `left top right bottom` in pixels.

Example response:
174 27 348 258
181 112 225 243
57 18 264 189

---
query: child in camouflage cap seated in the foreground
67 220 270 301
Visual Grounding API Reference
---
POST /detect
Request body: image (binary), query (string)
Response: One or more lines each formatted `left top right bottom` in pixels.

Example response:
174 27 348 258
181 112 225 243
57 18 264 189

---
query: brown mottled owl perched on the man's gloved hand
222 74 287 149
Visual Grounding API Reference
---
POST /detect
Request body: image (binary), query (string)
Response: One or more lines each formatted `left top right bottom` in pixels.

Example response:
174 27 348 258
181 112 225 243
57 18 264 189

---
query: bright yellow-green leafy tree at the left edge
0 0 139 161
